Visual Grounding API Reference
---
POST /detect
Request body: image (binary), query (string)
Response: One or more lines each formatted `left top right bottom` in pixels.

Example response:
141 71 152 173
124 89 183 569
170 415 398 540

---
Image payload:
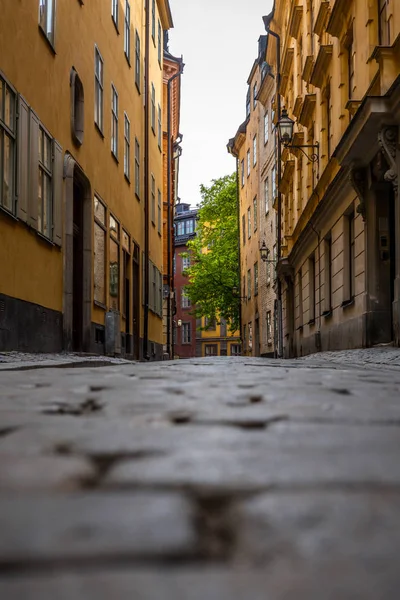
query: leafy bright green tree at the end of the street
185 174 240 332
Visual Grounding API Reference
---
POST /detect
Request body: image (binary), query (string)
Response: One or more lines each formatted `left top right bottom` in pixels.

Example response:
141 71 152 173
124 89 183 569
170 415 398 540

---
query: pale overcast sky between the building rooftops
170 0 273 206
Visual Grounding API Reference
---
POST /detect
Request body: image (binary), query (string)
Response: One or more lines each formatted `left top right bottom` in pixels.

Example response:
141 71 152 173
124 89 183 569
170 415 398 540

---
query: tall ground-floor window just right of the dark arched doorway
93 196 107 306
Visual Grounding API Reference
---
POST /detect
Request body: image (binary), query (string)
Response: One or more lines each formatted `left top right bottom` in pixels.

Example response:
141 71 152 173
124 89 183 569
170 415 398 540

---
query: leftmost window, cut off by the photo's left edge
0 76 16 213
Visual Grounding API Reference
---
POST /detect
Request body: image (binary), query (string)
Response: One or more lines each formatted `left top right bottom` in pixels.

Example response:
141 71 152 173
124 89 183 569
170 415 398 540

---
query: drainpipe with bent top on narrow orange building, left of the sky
167 59 185 359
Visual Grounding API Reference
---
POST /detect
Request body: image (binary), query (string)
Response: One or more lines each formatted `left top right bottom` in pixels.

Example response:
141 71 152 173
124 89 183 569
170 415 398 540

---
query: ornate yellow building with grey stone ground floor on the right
266 0 400 356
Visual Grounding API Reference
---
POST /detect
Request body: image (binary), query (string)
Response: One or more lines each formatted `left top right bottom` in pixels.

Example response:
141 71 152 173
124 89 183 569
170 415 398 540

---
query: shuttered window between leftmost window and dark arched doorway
38 126 53 239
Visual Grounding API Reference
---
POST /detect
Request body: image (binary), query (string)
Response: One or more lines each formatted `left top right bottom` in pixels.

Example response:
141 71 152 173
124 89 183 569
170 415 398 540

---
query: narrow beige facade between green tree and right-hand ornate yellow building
228 36 276 356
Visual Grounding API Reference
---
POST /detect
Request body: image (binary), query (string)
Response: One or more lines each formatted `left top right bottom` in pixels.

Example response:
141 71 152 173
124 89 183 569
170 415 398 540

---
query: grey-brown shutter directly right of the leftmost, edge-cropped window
17 96 29 223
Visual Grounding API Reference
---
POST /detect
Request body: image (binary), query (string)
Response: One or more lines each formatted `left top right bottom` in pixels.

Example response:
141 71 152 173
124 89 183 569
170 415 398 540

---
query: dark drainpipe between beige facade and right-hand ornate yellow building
263 21 283 358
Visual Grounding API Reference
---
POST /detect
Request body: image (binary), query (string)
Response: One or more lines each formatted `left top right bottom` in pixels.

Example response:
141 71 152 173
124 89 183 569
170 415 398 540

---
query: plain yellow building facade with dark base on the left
0 0 172 358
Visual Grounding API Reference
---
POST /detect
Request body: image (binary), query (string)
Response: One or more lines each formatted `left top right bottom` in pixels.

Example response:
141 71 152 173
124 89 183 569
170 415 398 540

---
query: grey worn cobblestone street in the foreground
0 348 400 600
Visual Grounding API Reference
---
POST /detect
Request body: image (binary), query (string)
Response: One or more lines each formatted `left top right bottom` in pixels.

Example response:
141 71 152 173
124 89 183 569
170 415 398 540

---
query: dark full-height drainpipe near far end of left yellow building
143 0 150 360
